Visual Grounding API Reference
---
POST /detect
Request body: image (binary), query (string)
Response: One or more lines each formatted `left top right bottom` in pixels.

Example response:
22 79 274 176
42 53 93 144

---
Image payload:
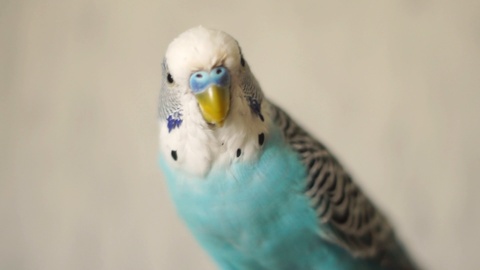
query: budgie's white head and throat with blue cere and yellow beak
159 26 269 175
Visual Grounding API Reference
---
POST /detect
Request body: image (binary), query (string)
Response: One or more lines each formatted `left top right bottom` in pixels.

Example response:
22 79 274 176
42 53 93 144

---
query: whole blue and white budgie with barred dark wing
159 26 416 269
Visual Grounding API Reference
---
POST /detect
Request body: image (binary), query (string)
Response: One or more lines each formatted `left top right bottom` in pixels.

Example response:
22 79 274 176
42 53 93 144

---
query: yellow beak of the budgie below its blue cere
195 84 230 127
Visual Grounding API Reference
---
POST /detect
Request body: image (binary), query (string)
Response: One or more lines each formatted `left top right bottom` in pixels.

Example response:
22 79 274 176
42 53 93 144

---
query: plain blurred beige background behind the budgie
0 0 480 269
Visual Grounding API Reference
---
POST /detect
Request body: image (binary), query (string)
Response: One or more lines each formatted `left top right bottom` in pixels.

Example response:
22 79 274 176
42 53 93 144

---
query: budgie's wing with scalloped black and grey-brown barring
272 106 394 257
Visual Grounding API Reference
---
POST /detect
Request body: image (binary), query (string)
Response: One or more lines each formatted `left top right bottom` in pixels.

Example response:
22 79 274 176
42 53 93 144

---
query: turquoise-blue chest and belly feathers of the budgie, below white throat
160 127 384 269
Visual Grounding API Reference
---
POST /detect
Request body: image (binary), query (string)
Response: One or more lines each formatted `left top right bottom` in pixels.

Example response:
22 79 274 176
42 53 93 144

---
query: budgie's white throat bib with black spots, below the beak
160 95 271 176
